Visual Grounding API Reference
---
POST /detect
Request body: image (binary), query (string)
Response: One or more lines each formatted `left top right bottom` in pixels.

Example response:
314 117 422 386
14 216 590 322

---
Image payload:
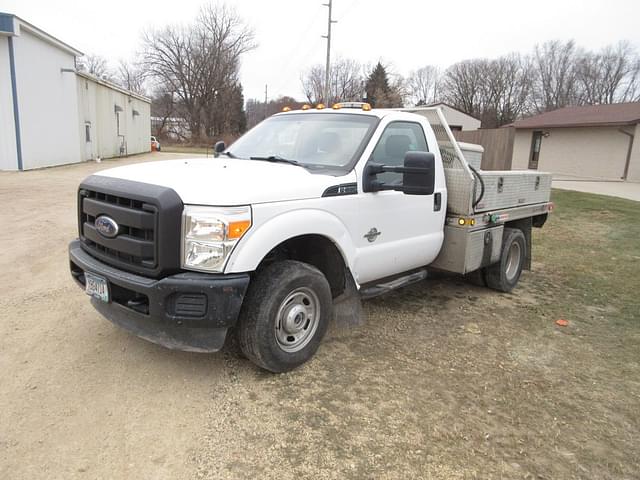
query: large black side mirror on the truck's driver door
362 152 436 195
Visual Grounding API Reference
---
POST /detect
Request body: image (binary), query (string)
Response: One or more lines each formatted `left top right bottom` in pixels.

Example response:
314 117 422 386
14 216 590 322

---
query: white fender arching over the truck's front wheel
224 208 355 273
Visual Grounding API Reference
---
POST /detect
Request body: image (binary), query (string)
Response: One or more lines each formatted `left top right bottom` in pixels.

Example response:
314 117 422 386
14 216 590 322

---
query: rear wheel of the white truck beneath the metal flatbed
483 227 527 293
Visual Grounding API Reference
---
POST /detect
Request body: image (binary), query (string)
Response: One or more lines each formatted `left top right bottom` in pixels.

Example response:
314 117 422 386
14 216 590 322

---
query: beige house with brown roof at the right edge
511 102 640 182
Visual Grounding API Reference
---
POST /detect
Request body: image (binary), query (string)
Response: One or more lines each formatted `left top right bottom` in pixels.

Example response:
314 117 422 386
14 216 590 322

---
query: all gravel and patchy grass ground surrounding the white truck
0 154 640 480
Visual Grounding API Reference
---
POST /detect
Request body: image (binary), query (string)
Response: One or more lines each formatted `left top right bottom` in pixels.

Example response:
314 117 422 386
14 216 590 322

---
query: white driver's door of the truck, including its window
354 121 444 285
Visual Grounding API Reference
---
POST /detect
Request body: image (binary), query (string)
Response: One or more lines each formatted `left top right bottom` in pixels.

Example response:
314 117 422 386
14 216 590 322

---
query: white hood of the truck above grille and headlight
96 158 356 206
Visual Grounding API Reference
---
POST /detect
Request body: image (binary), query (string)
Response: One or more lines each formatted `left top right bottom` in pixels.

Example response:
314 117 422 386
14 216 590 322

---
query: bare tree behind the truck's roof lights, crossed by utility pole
301 58 364 104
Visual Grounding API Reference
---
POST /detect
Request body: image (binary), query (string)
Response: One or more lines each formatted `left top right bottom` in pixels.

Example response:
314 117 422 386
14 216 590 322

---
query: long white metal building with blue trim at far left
0 12 151 170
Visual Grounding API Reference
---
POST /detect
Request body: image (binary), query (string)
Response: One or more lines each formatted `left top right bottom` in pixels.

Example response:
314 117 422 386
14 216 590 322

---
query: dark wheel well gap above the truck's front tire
258 235 347 298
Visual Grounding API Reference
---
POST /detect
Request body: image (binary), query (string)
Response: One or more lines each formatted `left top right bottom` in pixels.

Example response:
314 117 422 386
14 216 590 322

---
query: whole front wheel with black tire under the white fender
238 260 333 373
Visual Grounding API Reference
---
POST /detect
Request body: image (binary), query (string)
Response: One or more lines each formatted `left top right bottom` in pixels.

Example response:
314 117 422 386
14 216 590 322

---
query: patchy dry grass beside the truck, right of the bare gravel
197 191 640 480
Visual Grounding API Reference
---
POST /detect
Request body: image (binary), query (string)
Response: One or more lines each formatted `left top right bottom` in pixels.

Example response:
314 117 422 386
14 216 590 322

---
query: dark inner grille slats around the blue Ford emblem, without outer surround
80 189 158 269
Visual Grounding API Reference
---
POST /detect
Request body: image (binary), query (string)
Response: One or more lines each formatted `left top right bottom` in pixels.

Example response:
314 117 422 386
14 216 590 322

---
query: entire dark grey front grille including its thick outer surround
78 175 183 277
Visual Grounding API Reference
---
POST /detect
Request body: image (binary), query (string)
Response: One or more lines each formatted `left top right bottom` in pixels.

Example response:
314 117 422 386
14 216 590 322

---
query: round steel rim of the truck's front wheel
275 287 320 353
